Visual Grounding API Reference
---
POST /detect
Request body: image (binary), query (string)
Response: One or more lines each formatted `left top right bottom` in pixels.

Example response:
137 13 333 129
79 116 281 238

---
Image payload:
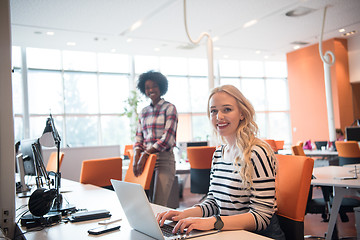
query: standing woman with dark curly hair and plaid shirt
133 71 178 206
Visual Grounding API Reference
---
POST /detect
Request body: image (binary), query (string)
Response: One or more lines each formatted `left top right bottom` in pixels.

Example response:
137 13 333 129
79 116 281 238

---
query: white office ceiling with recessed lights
10 0 360 61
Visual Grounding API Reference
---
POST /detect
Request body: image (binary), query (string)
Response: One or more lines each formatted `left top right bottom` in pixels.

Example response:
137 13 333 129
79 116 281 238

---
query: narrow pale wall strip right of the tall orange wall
348 34 360 83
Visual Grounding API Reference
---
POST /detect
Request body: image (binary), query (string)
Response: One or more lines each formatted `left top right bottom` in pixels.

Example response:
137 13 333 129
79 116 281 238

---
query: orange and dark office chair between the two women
186 146 216 201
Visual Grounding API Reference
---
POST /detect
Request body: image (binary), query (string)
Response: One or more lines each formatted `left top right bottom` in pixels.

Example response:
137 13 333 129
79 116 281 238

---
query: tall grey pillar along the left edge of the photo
0 0 15 239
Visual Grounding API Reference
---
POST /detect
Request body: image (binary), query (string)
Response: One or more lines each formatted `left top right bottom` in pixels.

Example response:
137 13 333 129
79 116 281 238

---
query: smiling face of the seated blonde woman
209 92 244 140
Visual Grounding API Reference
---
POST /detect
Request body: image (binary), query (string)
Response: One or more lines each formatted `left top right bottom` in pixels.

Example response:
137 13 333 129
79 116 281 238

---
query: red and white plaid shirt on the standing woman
134 99 178 152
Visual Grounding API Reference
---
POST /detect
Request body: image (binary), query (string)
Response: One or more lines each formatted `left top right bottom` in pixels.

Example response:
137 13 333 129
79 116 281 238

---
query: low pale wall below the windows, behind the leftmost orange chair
43 145 121 182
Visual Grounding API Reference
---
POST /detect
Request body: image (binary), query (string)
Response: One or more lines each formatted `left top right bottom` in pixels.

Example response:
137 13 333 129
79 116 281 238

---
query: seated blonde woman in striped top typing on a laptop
157 85 285 239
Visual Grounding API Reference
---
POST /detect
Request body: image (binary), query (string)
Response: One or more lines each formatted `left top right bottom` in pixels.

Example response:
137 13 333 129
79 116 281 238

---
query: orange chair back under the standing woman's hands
124 149 156 190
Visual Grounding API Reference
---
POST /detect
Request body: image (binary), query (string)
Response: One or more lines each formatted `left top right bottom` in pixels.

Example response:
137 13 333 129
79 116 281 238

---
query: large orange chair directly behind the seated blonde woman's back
275 154 314 240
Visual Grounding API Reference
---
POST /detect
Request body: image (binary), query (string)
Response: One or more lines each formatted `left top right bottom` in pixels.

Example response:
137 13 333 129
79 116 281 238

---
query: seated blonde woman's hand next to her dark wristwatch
173 217 216 234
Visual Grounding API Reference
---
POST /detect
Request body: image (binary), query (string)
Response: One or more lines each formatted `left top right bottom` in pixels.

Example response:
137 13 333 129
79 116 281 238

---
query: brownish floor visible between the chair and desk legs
179 188 356 239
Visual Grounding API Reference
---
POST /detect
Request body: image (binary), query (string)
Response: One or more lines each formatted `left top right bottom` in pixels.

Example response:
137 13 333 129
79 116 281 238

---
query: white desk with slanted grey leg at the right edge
311 166 360 239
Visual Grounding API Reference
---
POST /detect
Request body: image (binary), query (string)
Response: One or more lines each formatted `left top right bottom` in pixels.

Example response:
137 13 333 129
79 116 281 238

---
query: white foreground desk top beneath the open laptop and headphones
16 179 269 240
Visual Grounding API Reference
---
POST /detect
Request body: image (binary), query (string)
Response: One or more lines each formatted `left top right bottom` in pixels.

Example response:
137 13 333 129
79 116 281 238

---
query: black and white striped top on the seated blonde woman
198 146 277 231
